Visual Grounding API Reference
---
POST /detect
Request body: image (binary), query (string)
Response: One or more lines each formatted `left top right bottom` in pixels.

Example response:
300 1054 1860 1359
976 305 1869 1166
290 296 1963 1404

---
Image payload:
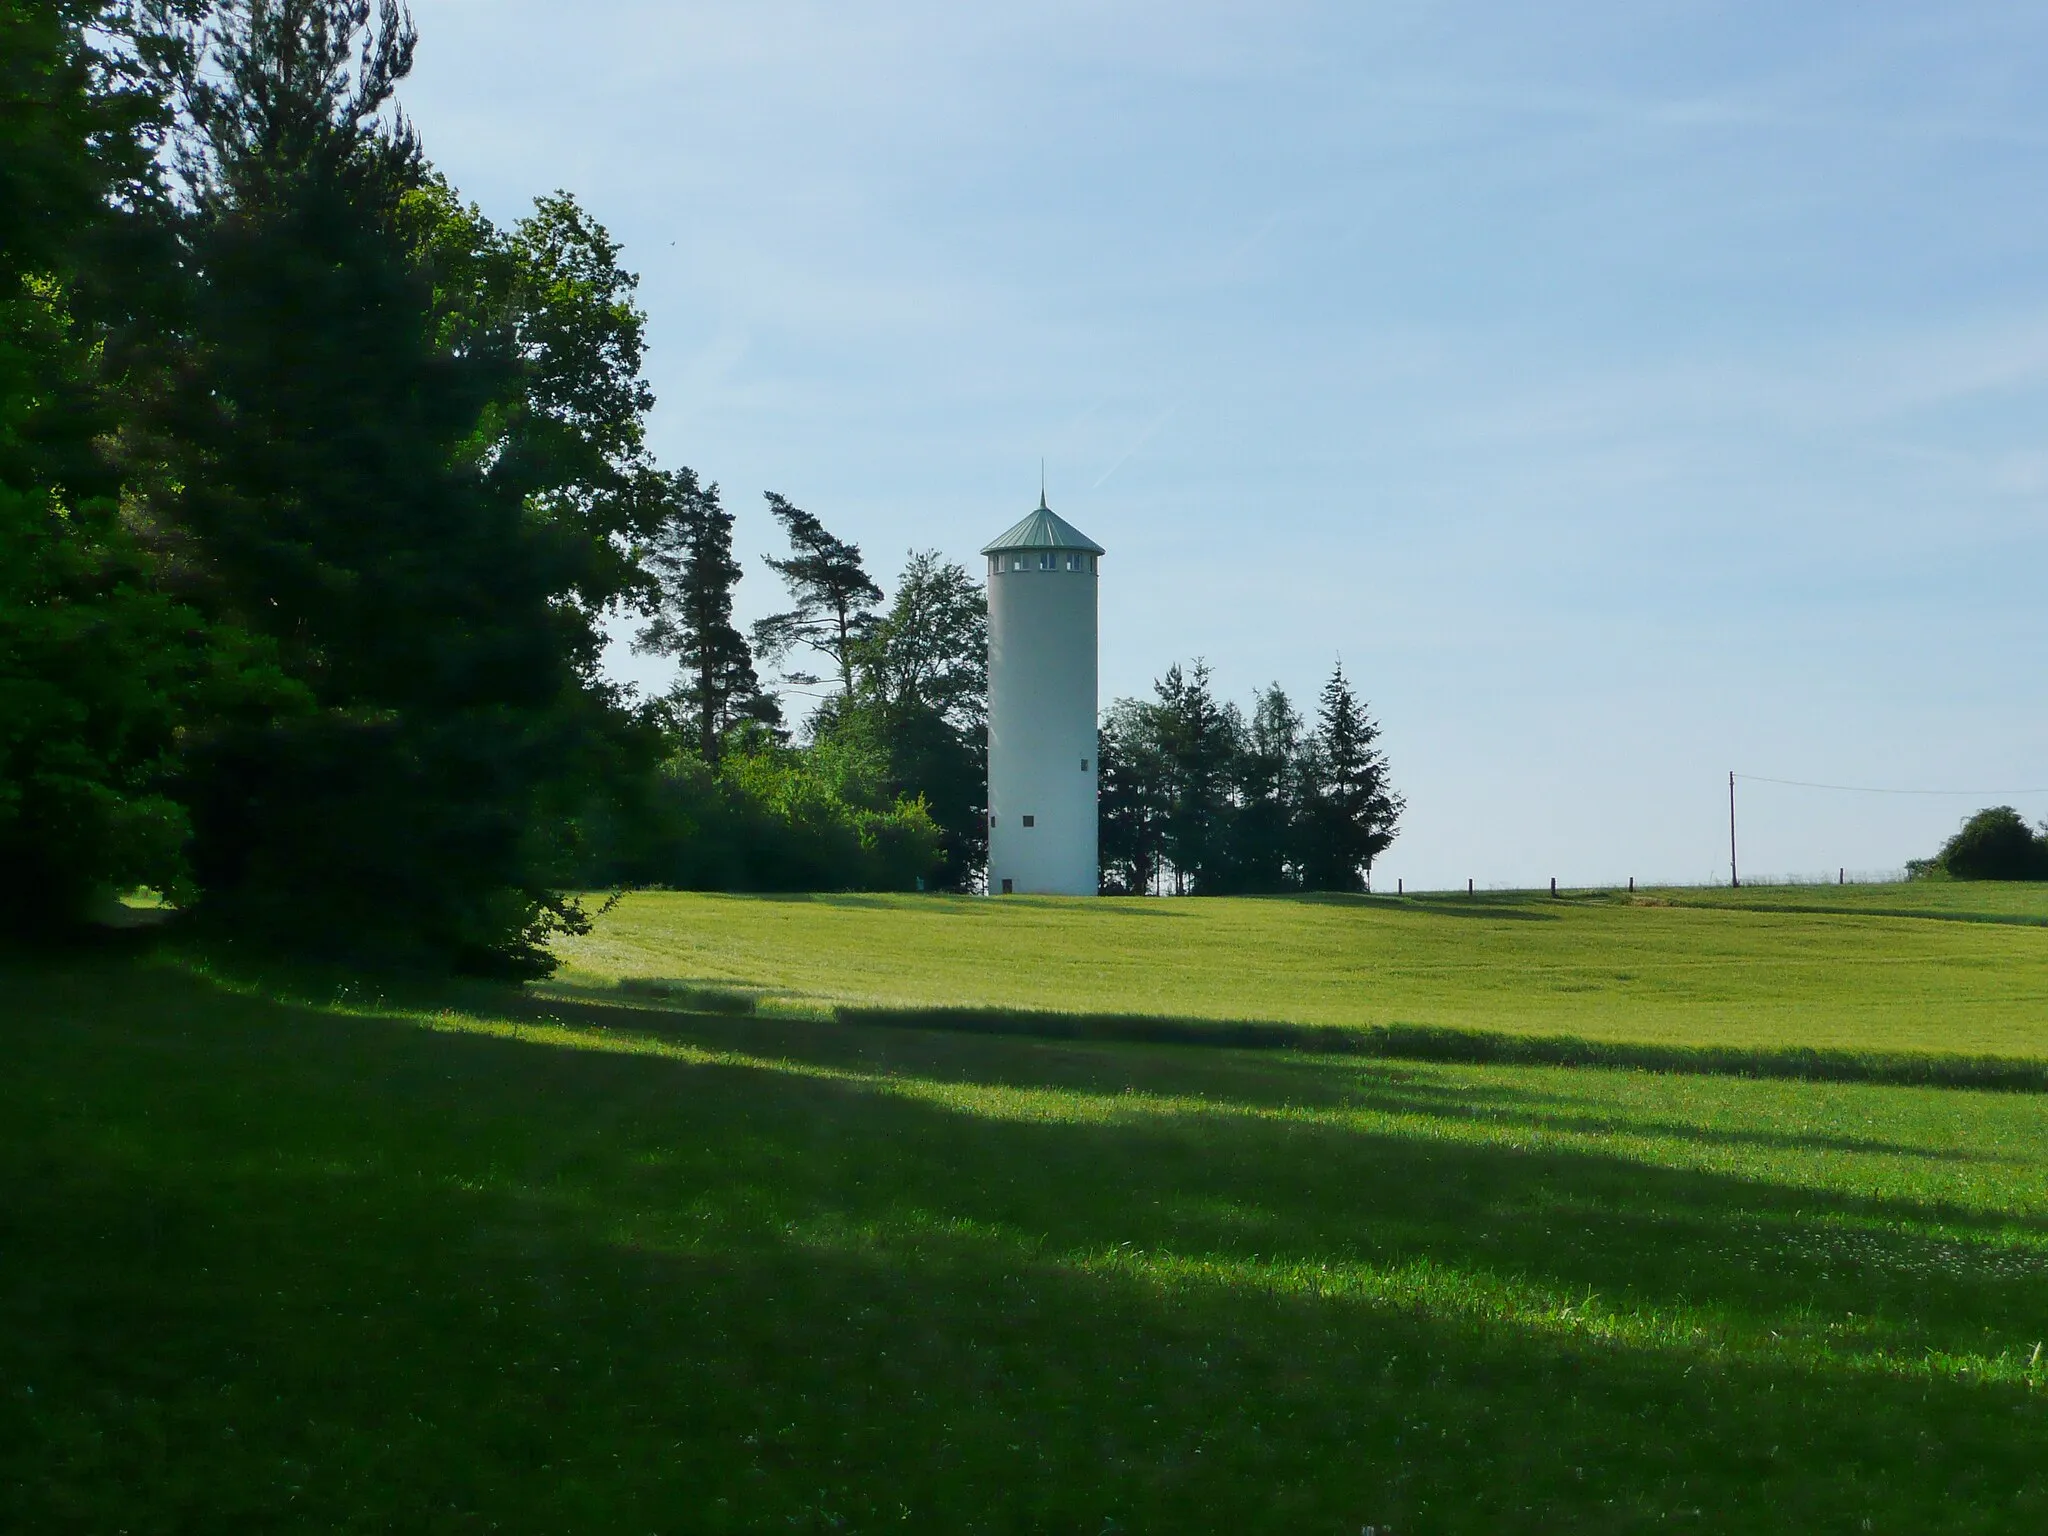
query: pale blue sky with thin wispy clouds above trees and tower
406 0 2048 885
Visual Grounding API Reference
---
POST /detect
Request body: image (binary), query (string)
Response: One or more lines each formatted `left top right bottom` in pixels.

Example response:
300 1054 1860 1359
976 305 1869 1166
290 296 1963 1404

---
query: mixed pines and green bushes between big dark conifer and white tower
610 487 987 891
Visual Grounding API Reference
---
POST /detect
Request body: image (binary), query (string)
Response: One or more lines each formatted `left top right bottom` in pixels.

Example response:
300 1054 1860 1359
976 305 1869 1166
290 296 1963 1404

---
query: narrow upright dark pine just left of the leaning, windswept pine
633 469 780 766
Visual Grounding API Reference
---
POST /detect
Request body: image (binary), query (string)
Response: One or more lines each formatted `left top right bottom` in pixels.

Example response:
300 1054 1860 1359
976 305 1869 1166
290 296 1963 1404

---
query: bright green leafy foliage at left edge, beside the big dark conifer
0 0 238 928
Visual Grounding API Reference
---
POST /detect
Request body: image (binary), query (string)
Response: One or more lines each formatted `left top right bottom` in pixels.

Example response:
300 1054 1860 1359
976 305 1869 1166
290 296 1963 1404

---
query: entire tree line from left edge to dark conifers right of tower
0 0 1399 975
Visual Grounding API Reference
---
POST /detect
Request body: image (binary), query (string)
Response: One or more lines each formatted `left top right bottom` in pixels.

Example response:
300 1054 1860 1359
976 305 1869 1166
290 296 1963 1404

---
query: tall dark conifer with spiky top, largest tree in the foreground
164 0 637 973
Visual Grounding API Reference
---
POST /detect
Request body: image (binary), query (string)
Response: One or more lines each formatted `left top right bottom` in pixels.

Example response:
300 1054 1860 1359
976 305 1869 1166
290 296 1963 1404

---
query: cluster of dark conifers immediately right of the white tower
1100 662 1403 895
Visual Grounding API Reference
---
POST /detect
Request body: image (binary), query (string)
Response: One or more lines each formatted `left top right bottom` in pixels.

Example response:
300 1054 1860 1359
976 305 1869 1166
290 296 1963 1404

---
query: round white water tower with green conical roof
981 492 1102 895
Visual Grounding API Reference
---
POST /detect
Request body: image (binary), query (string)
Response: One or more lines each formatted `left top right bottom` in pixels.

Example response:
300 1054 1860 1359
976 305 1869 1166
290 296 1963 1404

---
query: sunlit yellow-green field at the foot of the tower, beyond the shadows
561 885 2048 1057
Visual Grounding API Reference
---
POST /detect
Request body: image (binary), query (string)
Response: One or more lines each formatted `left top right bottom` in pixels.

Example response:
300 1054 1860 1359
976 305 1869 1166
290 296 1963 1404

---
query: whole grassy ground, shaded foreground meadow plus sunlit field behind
0 889 2048 1536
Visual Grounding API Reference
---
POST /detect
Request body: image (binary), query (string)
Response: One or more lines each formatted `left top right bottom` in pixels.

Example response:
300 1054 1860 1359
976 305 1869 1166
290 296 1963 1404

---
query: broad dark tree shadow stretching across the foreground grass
0 975 2048 1532
